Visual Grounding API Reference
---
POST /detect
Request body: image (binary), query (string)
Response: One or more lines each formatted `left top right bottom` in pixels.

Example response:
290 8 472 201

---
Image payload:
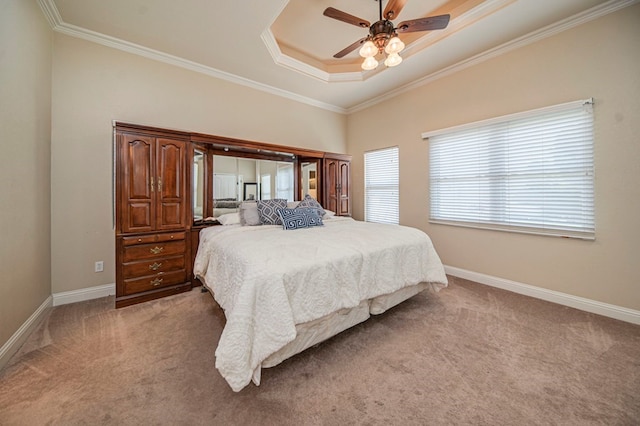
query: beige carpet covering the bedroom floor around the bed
0 279 640 425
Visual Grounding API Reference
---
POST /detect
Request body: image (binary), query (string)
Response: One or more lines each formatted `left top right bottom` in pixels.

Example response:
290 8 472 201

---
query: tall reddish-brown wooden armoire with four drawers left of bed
115 125 192 308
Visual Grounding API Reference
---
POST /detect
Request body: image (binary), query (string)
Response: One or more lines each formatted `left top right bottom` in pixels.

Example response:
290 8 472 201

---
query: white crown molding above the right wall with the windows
346 0 640 115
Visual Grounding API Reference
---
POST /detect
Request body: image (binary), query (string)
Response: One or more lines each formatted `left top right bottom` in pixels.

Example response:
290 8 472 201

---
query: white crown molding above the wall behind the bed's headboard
38 0 345 114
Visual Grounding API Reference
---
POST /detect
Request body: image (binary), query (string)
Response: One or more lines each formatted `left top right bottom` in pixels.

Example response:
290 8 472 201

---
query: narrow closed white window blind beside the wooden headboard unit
364 146 400 224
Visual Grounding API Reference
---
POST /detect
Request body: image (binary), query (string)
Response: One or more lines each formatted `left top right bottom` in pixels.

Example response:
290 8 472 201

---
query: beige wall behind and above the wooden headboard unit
51 34 346 293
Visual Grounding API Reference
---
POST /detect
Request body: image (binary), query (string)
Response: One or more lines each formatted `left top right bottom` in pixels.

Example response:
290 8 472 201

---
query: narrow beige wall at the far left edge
0 0 52 352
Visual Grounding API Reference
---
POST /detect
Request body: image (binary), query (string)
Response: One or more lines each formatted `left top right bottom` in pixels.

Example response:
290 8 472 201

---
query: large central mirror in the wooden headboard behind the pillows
213 155 294 217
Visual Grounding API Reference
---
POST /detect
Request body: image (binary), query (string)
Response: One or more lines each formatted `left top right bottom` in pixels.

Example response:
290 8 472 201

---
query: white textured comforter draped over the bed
194 217 447 392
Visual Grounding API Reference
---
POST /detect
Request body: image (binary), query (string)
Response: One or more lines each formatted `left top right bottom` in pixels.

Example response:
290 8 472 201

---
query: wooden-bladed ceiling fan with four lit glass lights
323 0 450 70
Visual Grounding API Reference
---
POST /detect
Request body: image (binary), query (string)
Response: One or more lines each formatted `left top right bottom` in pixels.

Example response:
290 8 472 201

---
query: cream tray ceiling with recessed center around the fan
38 0 638 113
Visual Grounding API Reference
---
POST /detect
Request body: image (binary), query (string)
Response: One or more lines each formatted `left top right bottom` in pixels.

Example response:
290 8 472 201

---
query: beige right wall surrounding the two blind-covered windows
348 5 640 310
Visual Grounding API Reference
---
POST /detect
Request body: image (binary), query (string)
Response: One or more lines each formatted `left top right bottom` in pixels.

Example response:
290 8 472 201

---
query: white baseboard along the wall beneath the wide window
444 265 640 325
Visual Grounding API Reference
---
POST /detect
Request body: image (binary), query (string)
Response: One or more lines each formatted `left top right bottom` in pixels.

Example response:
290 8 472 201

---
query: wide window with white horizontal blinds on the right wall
422 99 595 239
